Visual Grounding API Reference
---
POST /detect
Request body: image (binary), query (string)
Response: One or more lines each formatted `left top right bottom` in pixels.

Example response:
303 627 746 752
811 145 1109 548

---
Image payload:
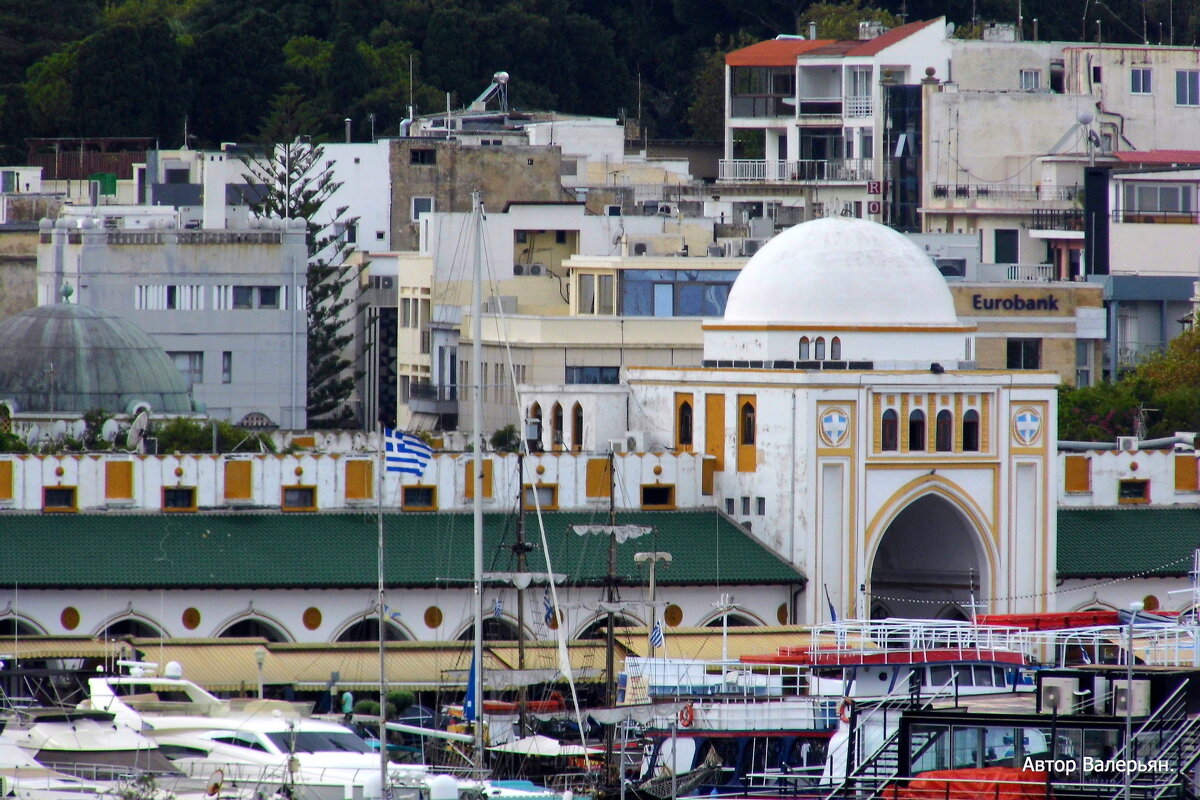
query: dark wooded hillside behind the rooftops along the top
0 0 1200 163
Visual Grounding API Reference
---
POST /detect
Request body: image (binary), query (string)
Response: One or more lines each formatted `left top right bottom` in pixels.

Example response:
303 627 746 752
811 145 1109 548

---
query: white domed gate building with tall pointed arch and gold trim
526 218 1058 622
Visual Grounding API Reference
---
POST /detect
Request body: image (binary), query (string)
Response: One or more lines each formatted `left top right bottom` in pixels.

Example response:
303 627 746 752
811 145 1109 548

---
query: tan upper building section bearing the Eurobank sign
949 281 1108 386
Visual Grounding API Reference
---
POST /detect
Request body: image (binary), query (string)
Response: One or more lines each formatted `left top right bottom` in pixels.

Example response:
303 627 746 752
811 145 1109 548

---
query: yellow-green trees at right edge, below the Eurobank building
1058 329 1200 441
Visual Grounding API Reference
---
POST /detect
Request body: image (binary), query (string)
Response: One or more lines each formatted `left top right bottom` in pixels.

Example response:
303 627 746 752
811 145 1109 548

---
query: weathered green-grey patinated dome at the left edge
0 303 193 414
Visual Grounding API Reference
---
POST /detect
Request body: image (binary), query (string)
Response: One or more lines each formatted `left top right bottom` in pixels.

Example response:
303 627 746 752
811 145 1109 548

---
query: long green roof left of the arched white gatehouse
0 510 804 588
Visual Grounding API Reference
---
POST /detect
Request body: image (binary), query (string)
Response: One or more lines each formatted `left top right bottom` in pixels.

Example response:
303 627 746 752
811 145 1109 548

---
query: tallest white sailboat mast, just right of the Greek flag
470 190 484 770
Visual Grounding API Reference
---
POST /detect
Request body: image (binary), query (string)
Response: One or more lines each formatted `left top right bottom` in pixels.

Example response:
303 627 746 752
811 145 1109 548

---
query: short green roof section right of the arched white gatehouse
1058 506 1200 578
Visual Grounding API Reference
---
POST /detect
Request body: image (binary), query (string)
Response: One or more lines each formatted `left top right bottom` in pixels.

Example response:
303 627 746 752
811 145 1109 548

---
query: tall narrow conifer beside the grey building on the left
242 86 365 428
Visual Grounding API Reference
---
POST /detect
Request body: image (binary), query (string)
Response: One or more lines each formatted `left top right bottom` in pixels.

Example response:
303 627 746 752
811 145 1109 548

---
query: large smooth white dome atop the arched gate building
725 217 959 329
